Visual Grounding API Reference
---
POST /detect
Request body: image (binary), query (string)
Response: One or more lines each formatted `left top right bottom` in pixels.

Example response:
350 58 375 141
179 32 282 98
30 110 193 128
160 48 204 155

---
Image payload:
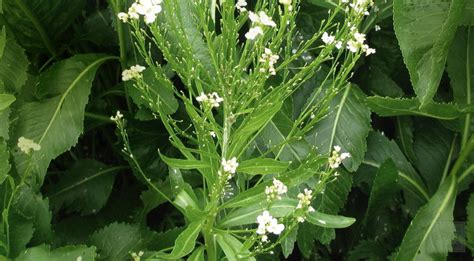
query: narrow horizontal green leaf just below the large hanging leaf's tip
367 96 466 120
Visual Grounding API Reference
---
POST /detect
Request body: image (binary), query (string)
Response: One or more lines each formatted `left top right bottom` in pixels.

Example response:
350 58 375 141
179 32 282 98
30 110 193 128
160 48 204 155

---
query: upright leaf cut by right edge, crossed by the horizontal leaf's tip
447 26 474 146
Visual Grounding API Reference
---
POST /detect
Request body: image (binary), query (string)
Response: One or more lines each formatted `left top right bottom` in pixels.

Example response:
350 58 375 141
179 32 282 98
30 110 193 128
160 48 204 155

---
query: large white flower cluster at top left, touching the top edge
117 0 162 24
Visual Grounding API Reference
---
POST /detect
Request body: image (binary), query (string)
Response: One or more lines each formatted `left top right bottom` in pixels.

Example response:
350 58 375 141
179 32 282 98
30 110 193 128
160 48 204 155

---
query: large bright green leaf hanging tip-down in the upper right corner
393 0 466 107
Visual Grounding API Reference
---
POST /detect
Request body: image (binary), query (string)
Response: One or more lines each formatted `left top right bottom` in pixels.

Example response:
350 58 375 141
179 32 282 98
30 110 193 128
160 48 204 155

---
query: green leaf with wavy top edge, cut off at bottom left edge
15 245 95 261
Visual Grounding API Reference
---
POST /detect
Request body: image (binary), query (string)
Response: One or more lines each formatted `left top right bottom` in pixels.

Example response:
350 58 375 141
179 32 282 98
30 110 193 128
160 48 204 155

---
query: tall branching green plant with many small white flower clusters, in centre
114 0 375 260
